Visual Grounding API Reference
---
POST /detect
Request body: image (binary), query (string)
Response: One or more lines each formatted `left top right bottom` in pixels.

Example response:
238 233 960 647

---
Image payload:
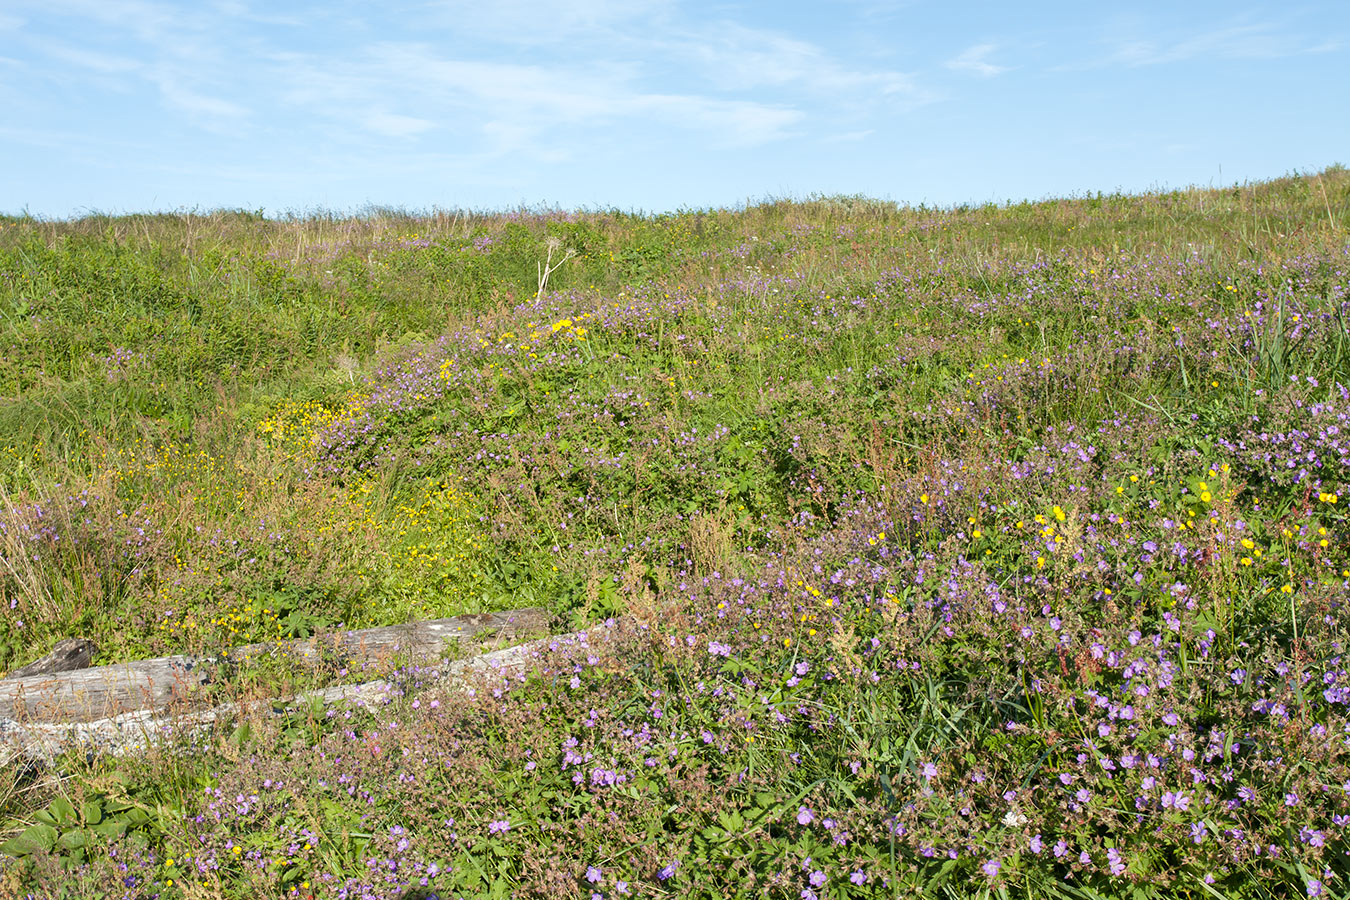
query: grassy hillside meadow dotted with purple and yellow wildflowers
0 167 1350 900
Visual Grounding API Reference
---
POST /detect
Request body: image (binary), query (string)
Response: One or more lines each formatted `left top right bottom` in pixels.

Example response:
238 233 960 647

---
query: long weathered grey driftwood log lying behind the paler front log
0 609 547 723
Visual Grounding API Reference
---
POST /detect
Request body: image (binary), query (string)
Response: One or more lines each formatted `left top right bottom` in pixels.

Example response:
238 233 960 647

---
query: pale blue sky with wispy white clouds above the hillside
0 0 1350 217
